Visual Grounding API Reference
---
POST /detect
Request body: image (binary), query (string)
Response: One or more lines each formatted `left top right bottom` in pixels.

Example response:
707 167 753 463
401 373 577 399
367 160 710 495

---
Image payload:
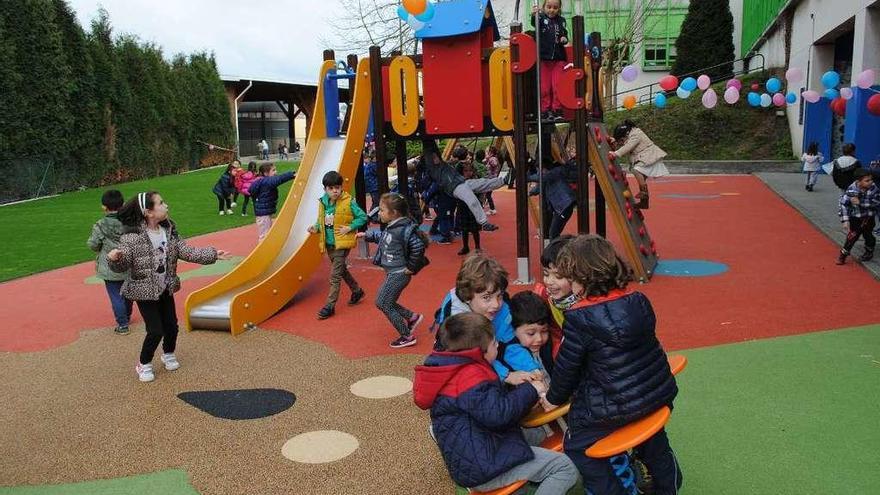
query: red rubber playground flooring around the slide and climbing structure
0 176 880 358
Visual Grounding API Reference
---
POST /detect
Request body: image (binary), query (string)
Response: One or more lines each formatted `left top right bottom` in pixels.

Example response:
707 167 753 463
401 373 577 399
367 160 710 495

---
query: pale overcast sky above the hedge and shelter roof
68 0 345 82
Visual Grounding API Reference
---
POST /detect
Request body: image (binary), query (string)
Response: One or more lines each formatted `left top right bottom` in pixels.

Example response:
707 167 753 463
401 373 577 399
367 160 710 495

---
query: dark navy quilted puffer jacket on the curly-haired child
547 290 678 449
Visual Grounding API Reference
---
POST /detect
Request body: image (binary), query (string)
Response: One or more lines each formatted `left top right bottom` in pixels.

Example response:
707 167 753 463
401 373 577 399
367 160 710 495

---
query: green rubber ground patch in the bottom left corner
0 469 199 495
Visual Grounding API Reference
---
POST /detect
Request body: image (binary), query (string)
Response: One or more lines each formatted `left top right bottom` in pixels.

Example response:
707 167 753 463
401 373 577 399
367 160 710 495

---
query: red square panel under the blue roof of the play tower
422 32 483 134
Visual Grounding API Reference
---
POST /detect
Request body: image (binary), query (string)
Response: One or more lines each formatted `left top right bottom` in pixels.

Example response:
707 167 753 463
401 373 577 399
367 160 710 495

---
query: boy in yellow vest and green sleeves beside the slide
309 171 367 320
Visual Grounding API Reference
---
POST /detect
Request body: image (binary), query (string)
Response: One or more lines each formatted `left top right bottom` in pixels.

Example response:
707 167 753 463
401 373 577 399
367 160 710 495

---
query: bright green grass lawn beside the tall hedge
0 161 299 282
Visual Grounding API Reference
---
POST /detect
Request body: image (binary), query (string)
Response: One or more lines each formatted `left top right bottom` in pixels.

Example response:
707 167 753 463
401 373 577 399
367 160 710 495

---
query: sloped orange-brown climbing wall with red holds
587 123 657 282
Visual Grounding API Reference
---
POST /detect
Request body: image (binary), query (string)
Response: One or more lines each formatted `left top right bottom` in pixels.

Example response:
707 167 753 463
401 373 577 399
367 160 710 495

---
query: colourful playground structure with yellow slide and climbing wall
185 0 657 335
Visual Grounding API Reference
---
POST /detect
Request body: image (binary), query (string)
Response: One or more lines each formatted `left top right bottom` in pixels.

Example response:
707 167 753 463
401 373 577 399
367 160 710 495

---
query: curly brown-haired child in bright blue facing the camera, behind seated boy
434 253 540 385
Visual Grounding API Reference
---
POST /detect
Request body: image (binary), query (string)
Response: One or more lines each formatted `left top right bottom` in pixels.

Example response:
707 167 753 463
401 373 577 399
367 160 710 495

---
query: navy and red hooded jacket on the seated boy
413 347 538 487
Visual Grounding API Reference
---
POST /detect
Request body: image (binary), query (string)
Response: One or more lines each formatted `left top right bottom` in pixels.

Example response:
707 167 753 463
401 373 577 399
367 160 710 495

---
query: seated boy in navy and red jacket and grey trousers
413 313 577 495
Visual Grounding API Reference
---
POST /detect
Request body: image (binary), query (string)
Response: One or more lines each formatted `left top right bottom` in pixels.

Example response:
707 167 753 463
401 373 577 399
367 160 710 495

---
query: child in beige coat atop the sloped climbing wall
609 119 669 210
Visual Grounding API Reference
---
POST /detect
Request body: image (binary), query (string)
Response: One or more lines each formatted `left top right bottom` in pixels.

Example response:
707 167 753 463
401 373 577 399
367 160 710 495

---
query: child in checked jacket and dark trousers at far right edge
837 168 880 265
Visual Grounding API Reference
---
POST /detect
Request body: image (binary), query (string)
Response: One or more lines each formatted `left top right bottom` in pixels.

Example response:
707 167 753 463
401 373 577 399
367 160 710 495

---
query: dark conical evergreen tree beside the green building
672 0 735 79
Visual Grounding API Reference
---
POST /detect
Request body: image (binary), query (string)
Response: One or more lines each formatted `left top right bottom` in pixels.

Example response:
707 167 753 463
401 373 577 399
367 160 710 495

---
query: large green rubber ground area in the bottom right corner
668 325 880 495
